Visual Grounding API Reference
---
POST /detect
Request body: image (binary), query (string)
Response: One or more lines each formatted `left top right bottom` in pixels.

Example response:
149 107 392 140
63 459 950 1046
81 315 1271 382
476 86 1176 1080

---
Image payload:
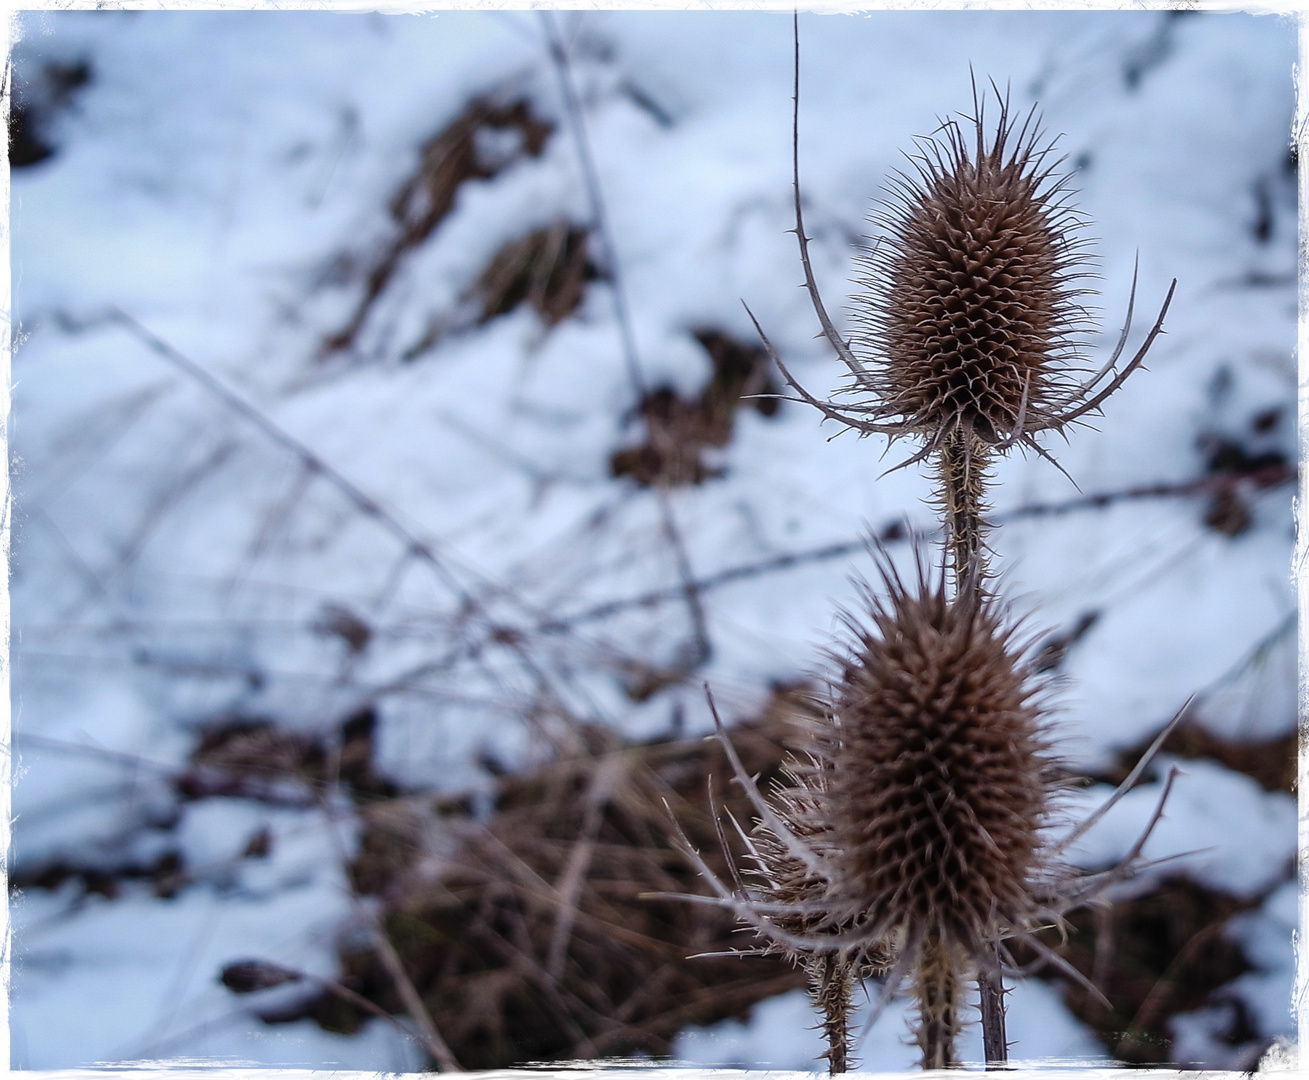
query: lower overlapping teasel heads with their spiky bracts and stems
674 559 1185 1073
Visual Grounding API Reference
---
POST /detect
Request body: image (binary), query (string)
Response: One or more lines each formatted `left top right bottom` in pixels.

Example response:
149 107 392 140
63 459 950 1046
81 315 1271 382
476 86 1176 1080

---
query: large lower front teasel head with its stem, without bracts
816 560 1051 1068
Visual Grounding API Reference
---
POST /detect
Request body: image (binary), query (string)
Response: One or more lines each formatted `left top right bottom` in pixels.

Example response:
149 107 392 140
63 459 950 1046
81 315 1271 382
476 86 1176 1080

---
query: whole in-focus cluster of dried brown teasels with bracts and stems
685 21 1185 1072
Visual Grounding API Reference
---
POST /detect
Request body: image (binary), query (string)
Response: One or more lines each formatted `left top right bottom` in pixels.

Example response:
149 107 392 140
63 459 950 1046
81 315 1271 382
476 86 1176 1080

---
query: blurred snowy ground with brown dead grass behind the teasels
8 12 1297 1070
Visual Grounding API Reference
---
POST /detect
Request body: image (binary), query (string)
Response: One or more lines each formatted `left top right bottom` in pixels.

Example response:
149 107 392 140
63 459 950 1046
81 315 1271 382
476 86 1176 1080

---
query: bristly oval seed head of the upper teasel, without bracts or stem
852 89 1088 444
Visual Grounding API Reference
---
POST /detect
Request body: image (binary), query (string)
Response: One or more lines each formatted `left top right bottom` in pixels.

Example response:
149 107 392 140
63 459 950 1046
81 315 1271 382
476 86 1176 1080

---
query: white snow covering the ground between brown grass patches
9 12 1296 1070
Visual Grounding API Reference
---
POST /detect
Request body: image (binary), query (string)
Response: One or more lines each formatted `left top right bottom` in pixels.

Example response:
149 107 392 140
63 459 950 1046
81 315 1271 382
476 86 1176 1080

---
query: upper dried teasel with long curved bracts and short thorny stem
746 33 1177 573
